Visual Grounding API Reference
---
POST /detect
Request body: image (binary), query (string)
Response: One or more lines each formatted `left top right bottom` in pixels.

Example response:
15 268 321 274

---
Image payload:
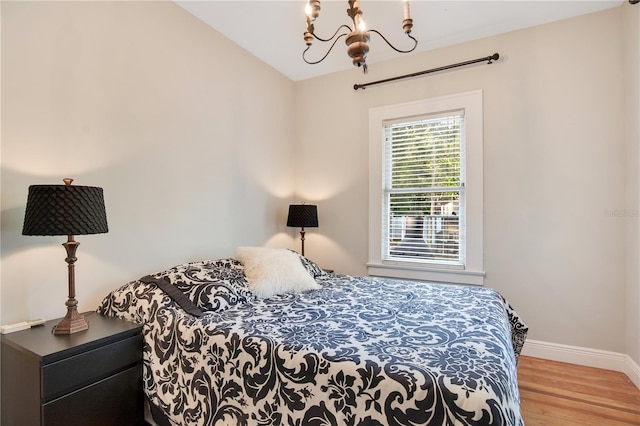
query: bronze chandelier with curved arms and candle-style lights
302 0 418 74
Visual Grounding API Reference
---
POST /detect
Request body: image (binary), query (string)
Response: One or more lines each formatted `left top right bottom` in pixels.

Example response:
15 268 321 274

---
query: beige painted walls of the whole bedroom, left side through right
1 2 640 363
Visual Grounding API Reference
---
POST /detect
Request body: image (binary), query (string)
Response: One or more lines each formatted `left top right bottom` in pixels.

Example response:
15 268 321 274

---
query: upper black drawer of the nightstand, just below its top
41 334 142 403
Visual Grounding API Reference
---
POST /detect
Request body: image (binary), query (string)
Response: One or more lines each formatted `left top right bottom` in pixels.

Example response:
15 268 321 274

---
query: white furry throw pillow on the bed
236 247 321 298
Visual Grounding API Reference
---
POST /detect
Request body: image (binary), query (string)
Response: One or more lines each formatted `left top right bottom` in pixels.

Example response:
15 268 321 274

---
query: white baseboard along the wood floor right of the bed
522 340 640 388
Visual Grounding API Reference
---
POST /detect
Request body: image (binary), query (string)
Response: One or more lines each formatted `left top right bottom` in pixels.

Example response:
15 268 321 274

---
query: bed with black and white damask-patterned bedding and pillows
98 249 527 426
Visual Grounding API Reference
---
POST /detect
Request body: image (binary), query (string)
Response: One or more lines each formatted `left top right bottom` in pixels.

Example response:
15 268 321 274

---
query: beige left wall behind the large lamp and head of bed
1 1 294 324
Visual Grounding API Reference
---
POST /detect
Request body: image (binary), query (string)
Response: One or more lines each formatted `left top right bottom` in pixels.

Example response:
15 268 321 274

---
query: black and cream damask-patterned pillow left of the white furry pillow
153 259 254 311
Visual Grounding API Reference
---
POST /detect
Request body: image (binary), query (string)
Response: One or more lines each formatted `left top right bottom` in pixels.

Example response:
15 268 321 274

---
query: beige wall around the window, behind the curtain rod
296 8 637 353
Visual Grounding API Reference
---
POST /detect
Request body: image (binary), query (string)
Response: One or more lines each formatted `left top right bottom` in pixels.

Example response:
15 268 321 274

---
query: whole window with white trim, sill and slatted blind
368 91 484 284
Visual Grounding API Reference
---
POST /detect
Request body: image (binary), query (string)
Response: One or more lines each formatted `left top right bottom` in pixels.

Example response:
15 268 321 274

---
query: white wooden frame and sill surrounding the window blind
367 90 485 285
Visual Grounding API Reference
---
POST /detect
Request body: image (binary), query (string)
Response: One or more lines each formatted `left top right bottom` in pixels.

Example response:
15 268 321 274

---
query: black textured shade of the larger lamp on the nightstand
22 185 109 235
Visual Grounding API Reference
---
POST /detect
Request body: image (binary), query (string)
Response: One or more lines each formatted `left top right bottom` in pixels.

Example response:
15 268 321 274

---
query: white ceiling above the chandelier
175 0 622 81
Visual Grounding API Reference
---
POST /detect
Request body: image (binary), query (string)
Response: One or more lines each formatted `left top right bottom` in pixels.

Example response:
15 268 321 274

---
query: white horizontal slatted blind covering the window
382 110 465 265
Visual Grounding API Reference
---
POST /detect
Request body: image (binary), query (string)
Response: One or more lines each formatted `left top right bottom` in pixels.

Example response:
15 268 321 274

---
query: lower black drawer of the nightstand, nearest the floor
42 365 144 426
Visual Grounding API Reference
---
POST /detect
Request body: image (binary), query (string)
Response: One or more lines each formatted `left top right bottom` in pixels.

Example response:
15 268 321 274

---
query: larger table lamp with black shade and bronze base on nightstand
22 179 109 334
